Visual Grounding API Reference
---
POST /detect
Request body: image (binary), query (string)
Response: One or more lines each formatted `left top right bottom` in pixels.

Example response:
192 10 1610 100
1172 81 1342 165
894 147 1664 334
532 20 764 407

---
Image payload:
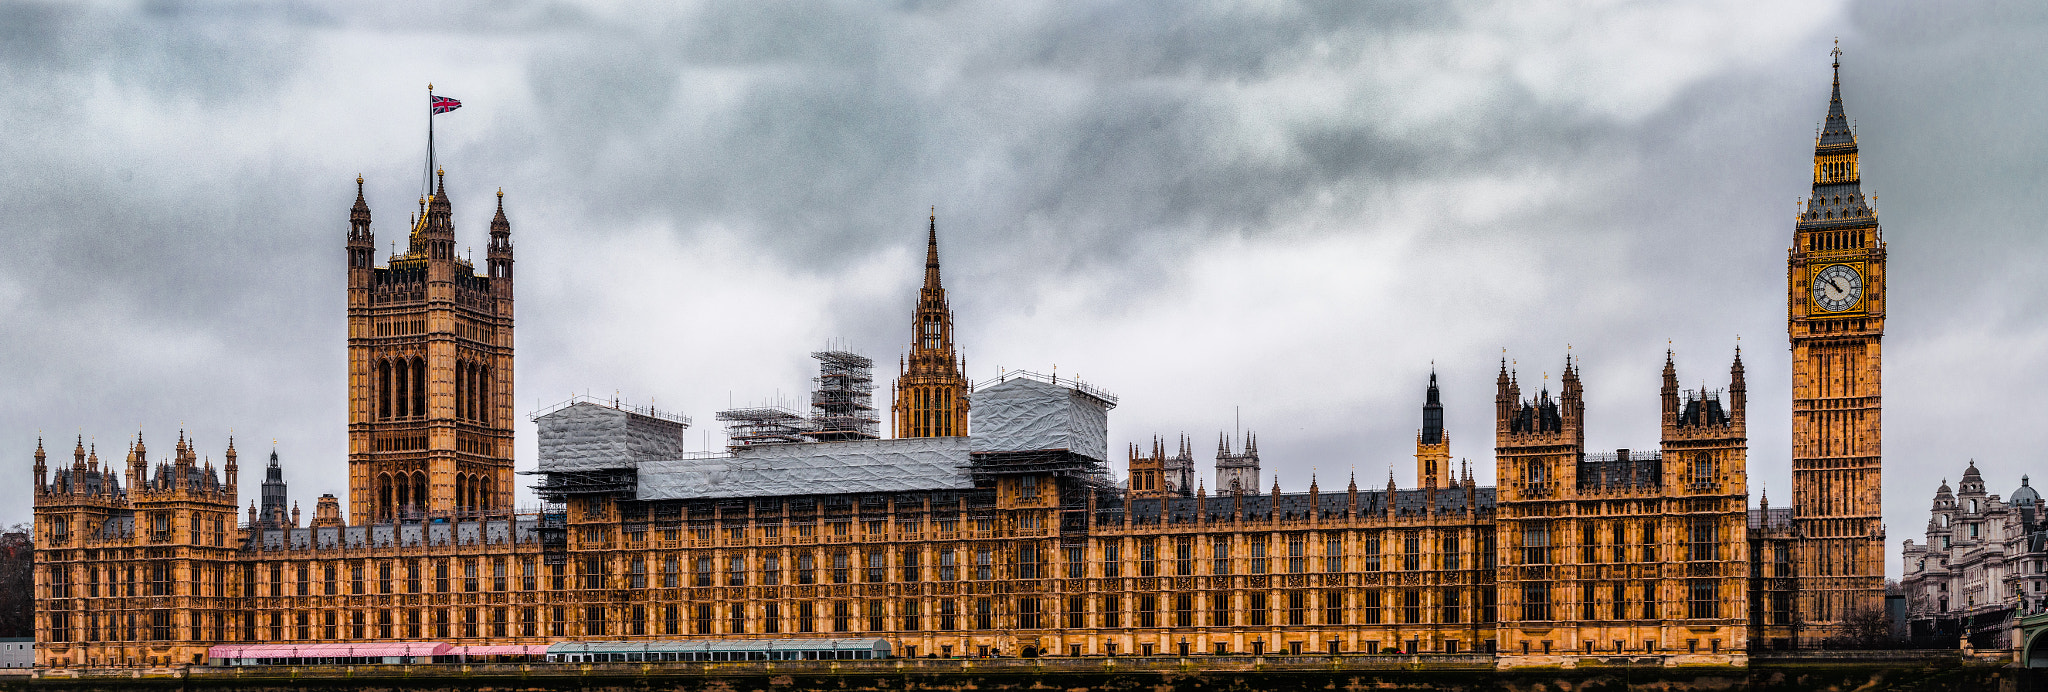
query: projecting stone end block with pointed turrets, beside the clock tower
1495 354 1749 665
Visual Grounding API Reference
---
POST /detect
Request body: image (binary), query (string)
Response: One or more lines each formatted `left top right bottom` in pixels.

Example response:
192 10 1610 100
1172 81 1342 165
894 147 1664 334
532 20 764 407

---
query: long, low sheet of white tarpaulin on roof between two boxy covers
635 438 975 500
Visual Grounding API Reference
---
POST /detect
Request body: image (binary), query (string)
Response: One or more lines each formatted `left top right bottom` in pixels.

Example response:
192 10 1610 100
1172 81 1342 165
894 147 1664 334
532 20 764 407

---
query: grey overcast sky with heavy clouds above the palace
0 0 2048 573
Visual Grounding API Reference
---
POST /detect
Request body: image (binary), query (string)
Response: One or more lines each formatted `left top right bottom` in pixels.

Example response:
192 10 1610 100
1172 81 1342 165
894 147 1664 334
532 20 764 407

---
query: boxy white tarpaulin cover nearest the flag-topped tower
535 401 688 471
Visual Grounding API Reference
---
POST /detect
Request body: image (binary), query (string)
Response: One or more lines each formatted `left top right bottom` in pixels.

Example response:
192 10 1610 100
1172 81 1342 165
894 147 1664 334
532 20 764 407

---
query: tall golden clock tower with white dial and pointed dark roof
1786 47 1884 643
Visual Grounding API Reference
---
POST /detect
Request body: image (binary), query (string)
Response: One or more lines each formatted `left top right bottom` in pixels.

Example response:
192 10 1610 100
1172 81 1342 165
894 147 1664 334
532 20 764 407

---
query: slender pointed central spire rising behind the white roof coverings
889 211 967 438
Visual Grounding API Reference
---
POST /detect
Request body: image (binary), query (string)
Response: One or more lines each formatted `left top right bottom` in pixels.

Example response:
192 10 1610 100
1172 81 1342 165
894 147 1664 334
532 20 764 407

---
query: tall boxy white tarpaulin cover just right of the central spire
969 377 1110 461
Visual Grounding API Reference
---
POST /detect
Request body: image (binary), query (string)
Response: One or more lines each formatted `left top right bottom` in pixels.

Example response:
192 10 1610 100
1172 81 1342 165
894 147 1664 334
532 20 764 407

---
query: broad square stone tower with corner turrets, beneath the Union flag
348 170 512 524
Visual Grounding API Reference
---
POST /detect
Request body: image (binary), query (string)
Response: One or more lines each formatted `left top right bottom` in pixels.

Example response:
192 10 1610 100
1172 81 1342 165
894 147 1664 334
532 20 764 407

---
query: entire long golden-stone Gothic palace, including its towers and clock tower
33 53 1886 667
